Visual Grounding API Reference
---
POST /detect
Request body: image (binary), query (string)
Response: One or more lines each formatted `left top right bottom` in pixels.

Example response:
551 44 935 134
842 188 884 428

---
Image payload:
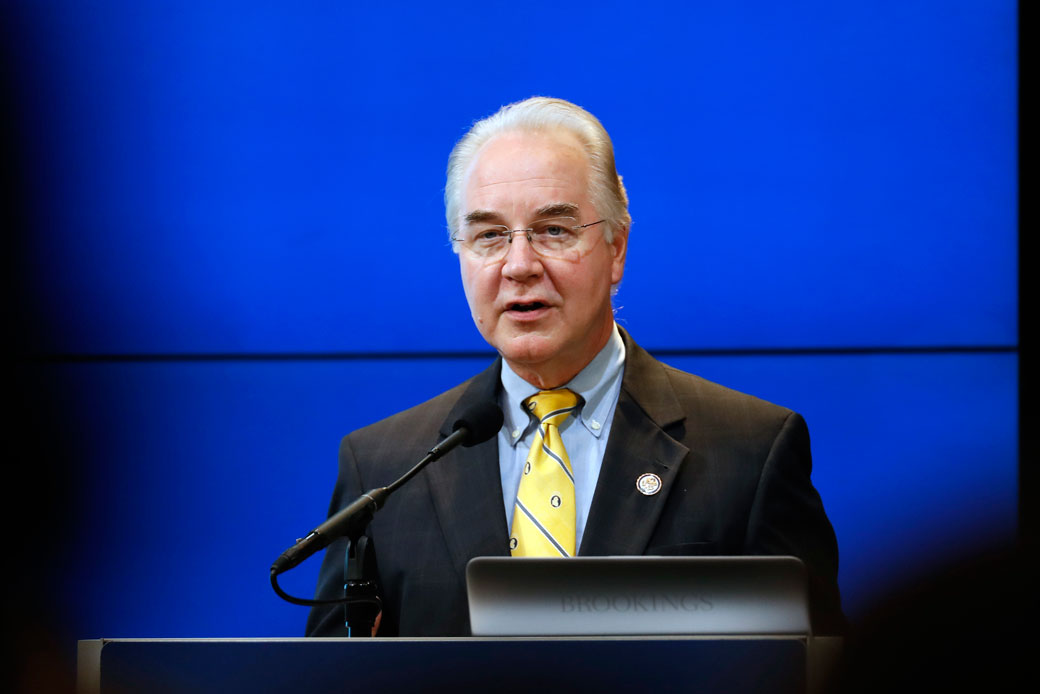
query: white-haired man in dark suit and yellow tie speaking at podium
307 98 843 636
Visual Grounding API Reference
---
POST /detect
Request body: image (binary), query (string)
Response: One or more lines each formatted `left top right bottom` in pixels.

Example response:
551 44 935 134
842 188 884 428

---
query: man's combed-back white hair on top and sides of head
444 97 632 242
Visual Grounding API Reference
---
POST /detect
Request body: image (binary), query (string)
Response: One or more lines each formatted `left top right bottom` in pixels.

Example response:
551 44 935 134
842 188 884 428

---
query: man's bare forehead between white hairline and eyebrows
462 131 591 216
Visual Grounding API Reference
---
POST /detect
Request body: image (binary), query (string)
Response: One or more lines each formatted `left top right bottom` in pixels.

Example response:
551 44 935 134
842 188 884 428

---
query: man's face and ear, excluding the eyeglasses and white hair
459 132 627 388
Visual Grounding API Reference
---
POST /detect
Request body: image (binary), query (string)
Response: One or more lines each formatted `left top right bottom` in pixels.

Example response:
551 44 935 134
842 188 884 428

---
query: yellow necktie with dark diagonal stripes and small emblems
510 388 578 557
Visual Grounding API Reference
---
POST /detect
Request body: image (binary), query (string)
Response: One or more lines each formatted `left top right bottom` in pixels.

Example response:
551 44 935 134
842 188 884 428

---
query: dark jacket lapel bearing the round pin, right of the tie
578 331 690 556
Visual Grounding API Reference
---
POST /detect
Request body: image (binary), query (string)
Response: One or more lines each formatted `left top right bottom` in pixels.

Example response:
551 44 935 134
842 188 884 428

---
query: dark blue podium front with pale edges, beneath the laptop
77 636 840 694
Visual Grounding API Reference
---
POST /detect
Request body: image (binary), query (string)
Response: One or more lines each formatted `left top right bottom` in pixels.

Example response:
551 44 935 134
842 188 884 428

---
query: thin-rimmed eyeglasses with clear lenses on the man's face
451 216 605 262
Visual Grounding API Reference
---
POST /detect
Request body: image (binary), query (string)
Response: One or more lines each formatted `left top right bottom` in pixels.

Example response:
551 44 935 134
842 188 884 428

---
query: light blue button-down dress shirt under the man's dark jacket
498 325 625 548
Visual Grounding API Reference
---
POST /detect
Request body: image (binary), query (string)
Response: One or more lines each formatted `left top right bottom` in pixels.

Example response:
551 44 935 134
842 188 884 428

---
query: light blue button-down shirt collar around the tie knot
501 324 625 445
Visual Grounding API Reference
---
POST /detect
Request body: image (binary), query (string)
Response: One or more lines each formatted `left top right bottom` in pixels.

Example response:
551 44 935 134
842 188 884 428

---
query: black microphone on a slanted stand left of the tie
270 401 502 576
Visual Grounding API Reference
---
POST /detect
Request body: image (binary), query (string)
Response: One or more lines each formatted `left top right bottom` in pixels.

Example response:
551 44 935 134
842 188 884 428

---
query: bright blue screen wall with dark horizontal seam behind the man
5 0 1018 653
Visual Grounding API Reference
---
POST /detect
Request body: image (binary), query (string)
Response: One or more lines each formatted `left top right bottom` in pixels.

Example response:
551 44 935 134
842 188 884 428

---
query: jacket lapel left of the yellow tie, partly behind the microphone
425 360 509 575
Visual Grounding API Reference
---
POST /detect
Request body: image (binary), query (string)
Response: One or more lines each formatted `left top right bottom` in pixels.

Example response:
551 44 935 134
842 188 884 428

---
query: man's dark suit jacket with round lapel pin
307 332 844 636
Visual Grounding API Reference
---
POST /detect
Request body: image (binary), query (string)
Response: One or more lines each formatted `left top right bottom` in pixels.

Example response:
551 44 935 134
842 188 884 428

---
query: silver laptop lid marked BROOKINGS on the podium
466 557 810 636
